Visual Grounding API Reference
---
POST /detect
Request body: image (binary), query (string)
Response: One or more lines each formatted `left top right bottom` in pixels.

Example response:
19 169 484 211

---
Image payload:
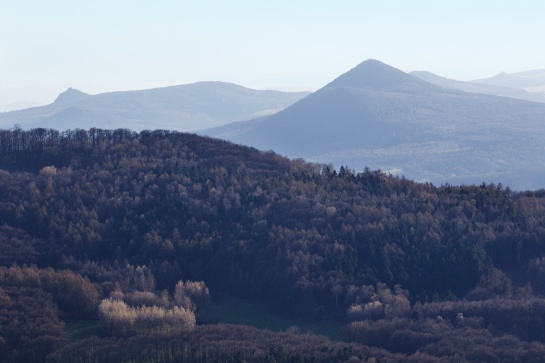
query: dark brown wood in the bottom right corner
347 314 545 363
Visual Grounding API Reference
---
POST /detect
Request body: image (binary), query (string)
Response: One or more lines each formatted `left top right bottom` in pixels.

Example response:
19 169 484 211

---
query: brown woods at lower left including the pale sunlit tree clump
0 265 210 362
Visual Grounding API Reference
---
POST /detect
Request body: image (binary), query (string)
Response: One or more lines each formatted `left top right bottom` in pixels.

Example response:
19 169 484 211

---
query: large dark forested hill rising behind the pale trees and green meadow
0 129 545 362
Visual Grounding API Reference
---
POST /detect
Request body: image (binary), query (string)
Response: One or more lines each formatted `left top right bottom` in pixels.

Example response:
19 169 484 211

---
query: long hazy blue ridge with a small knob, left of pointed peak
0 82 308 131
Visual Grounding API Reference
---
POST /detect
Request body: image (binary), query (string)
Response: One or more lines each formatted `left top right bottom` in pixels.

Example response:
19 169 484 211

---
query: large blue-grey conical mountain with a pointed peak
203 60 545 189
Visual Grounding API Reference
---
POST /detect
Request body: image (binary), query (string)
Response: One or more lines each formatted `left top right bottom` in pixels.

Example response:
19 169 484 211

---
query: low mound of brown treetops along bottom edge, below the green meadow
48 324 378 363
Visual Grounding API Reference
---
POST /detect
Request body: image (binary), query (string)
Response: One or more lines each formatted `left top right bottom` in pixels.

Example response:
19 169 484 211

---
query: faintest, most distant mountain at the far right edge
473 69 545 93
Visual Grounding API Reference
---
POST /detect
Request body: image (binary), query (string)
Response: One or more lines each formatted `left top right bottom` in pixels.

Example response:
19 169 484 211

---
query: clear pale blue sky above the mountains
0 0 545 106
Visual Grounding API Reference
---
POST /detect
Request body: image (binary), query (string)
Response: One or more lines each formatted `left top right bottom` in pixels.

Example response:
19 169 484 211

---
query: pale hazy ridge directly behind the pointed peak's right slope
410 71 545 102
